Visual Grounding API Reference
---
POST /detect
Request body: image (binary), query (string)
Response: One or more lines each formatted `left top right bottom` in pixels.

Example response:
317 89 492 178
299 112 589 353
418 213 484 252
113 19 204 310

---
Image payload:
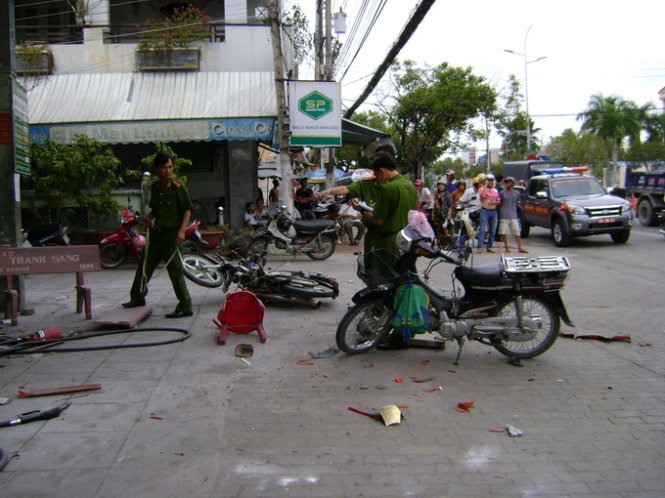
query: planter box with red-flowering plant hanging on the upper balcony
136 5 211 71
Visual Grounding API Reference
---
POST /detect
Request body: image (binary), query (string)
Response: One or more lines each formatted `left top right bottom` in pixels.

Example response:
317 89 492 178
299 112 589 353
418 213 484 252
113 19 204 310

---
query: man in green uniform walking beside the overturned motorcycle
123 152 192 318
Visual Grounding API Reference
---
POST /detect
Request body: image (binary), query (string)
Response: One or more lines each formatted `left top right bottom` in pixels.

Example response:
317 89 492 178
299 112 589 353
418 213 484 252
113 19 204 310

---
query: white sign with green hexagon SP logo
289 81 342 147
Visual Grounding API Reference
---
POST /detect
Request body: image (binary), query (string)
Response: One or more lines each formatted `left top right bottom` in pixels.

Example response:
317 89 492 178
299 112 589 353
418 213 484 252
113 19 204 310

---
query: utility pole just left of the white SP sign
268 0 293 214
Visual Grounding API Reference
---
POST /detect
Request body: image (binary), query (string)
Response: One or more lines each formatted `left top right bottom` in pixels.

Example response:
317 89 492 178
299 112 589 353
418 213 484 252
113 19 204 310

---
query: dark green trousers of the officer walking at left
129 228 192 313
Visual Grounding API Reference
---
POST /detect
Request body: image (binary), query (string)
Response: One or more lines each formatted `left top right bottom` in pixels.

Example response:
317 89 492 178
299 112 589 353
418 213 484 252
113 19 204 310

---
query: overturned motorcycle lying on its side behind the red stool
182 252 339 308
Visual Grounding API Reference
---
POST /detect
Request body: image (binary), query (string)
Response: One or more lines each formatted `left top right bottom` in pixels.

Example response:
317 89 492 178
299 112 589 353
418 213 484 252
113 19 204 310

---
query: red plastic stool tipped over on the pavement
213 291 268 345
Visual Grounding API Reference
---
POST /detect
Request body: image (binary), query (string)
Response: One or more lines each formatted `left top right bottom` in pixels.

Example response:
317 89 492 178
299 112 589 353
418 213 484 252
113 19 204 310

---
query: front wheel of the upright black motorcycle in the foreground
335 298 393 354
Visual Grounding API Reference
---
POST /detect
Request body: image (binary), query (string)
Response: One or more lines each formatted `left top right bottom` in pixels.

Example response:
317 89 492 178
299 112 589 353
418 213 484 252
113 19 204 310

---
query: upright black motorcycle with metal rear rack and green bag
336 227 573 363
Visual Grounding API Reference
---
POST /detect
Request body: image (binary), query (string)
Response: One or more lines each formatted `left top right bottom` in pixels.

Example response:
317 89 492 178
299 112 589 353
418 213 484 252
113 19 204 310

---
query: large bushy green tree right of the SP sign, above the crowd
388 61 496 178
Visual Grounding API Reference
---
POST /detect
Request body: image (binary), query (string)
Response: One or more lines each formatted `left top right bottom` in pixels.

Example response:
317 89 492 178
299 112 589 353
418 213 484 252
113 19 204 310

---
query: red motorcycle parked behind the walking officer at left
99 208 208 268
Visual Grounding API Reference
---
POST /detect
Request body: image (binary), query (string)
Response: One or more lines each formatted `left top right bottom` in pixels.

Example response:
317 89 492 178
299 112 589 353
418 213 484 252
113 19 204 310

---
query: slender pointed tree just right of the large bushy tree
496 74 540 160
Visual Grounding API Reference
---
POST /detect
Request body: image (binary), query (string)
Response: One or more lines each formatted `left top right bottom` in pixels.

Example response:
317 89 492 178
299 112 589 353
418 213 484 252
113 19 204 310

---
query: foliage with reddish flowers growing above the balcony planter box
138 5 211 49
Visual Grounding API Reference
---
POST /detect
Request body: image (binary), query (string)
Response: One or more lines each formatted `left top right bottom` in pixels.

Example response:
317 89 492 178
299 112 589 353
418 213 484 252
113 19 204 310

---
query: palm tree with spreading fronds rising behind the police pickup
577 94 642 166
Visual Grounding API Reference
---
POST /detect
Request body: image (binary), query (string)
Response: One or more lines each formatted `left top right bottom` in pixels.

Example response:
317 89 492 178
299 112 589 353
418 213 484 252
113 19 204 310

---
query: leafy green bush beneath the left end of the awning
30 135 123 225
